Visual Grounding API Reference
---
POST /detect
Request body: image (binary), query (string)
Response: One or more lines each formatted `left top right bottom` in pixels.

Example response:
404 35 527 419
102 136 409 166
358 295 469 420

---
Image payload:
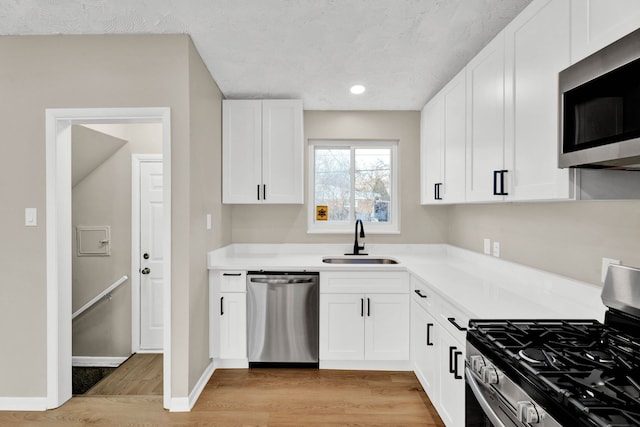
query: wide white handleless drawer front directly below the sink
320 271 409 294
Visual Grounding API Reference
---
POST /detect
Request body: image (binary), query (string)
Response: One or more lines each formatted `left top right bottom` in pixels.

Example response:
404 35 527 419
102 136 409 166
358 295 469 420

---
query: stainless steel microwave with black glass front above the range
558 26 640 170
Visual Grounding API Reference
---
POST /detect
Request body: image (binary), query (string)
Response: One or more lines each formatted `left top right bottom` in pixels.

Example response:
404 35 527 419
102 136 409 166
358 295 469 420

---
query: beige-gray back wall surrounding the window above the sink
232 111 447 243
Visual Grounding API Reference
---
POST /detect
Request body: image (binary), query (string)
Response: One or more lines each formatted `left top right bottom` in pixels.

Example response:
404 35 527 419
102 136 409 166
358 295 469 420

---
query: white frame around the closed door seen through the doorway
130 153 166 353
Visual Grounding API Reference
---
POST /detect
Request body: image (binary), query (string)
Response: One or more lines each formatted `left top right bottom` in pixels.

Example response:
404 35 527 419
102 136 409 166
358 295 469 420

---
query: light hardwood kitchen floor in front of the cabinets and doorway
0 369 443 427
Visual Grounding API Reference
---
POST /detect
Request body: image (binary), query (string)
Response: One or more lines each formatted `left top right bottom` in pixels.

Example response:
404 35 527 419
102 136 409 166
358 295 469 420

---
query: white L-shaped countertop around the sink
208 244 606 321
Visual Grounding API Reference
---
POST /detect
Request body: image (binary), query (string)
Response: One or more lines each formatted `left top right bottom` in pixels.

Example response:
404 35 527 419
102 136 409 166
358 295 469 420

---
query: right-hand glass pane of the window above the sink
355 148 392 222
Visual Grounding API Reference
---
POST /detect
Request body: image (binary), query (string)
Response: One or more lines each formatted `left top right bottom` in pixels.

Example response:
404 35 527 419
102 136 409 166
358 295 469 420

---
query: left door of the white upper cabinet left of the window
222 100 262 203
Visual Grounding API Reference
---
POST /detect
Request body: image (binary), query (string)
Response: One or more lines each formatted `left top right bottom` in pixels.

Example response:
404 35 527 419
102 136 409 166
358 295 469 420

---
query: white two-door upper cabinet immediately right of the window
421 70 466 204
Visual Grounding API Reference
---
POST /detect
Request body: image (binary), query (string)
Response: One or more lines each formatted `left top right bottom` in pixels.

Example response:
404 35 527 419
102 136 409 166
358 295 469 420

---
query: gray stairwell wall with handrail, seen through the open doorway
72 124 162 357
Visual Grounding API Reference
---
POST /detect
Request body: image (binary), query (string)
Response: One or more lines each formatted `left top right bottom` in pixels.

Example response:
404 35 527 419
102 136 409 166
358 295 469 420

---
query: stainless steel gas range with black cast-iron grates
465 266 640 427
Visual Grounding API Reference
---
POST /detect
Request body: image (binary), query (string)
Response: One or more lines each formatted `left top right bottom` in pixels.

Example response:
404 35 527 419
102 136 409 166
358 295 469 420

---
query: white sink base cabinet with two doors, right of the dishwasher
320 272 410 369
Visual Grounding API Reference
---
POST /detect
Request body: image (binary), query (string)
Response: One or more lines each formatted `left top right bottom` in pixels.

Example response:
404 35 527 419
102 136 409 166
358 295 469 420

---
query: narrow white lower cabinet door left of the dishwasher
219 293 247 359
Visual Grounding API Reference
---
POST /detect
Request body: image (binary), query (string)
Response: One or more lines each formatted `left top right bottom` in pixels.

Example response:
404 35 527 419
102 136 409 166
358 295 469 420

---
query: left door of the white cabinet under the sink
320 294 365 360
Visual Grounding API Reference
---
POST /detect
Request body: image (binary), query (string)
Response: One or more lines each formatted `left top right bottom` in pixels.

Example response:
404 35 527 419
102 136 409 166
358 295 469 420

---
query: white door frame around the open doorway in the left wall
45 107 171 409
